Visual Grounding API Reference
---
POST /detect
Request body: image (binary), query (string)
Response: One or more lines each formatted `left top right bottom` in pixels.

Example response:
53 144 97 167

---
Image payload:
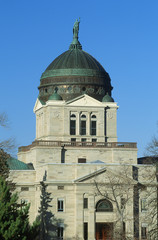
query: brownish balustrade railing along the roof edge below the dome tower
18 140 137 152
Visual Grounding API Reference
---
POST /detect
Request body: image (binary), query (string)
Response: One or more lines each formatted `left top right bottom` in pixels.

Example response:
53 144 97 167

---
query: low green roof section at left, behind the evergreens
7 157 34 170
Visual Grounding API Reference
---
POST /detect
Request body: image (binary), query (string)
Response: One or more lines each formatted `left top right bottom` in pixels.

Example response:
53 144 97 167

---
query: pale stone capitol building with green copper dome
10 22 156 240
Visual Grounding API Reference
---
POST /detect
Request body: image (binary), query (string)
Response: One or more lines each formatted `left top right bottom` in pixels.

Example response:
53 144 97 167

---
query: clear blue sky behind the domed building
0 0 158 157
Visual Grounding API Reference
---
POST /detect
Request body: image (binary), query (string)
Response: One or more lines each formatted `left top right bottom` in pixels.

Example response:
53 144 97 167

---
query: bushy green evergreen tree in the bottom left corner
0 176 39 240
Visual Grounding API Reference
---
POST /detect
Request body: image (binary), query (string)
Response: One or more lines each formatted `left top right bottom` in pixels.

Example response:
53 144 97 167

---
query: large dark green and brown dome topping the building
38 20 112 101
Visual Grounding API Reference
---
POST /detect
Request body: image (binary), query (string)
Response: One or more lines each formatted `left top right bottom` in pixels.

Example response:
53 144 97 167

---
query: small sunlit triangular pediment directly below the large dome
66 94 102 107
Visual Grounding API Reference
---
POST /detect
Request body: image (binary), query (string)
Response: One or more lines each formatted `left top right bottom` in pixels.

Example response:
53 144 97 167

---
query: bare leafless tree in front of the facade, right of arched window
95 165 139 240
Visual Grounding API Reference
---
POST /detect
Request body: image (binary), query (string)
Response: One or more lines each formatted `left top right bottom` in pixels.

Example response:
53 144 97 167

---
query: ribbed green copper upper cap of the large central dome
41 49 109 81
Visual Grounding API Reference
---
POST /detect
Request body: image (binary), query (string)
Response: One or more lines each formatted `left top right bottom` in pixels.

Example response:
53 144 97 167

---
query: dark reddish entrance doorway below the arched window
96 223 113 240
